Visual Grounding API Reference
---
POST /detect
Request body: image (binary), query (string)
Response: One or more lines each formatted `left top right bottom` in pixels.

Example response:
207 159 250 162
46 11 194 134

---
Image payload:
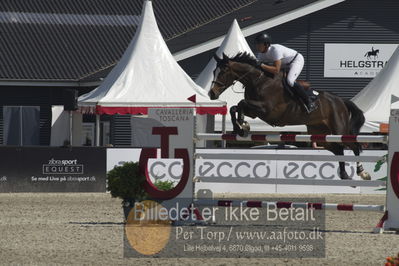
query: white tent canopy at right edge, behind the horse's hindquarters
352 47 399 132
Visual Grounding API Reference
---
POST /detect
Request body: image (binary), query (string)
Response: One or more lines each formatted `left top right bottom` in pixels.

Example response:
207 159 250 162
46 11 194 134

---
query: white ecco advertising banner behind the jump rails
107 148 387 194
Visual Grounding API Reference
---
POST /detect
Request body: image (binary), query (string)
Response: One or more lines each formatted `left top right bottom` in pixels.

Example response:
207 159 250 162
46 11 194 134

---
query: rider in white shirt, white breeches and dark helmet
255 33 316 113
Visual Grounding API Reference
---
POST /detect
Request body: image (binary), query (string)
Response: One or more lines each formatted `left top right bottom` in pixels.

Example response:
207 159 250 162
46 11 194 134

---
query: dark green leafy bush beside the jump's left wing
107 162 174 218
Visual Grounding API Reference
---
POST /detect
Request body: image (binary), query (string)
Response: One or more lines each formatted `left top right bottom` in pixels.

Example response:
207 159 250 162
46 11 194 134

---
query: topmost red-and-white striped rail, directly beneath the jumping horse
196 133 388 143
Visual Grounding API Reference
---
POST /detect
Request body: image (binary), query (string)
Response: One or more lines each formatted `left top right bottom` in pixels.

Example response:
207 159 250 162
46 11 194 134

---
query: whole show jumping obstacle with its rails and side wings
140 103 399 232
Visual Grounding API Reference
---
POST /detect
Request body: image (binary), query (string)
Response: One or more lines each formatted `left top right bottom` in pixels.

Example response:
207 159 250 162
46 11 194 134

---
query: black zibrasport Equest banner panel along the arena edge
0 147 106 192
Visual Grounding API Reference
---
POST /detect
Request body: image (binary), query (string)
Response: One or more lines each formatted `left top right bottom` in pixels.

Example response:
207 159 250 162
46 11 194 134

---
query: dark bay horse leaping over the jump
209 53 370 180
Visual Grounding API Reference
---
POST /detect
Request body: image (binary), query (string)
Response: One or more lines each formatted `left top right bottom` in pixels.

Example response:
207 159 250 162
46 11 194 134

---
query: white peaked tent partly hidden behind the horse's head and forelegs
195 20 306 131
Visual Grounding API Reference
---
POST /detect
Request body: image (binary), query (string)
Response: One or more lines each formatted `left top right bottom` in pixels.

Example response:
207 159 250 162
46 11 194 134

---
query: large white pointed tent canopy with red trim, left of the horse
79 1 226 114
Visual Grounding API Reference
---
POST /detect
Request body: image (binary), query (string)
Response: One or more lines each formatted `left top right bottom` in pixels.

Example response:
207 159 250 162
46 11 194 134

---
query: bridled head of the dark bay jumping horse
208 54 237 100
